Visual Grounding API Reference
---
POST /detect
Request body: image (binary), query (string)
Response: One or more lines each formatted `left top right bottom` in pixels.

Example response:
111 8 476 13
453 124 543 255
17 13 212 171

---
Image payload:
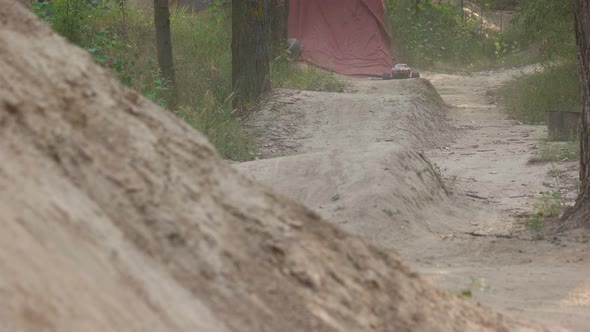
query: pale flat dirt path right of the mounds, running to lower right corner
417 68 590 331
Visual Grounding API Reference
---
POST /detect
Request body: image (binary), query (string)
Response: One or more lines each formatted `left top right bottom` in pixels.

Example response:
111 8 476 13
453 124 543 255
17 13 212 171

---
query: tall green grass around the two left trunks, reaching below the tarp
34 0 344 161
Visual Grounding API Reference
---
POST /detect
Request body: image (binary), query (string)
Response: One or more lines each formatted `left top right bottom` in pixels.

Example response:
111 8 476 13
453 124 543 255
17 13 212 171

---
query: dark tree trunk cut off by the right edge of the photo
565 0 590 227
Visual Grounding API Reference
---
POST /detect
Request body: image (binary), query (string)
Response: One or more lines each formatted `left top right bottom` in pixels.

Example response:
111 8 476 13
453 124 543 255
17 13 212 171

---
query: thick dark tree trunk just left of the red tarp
232 0 270 111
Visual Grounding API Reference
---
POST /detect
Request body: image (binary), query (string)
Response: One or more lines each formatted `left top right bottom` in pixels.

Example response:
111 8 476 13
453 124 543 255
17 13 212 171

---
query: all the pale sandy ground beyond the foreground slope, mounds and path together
235 66 590 331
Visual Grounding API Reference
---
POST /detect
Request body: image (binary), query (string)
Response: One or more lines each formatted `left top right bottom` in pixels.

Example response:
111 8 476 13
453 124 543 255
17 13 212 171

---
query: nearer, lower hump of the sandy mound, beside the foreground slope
236 142 458 252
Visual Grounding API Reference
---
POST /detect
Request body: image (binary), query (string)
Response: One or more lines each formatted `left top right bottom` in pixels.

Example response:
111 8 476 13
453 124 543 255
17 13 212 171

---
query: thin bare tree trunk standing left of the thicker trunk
154 0 176 108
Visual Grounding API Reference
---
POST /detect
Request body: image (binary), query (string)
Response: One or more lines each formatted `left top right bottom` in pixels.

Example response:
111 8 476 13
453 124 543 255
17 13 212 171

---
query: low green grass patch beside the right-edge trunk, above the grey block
499 62 580 123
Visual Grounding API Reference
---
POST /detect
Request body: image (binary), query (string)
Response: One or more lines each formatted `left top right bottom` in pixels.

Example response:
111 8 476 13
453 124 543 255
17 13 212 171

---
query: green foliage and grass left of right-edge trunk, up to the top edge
500 0 580 126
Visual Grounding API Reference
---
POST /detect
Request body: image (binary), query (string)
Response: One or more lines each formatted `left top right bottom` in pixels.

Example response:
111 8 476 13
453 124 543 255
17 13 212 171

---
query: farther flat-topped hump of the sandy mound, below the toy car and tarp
245 79 452 158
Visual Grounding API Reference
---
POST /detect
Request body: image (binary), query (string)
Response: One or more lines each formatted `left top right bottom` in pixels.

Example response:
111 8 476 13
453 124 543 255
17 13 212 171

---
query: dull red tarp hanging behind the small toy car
289 0 392 76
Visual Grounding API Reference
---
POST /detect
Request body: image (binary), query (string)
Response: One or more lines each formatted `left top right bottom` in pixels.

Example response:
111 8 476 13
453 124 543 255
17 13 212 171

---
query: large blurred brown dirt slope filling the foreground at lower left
0 0 564 332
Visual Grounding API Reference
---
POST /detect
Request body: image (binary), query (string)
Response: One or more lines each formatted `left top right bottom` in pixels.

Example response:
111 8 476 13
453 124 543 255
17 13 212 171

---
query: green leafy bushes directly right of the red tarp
386 0 514 66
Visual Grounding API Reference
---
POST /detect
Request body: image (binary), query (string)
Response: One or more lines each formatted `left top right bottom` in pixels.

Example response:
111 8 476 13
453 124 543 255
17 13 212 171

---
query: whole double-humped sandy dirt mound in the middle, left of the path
235 79 467 254
